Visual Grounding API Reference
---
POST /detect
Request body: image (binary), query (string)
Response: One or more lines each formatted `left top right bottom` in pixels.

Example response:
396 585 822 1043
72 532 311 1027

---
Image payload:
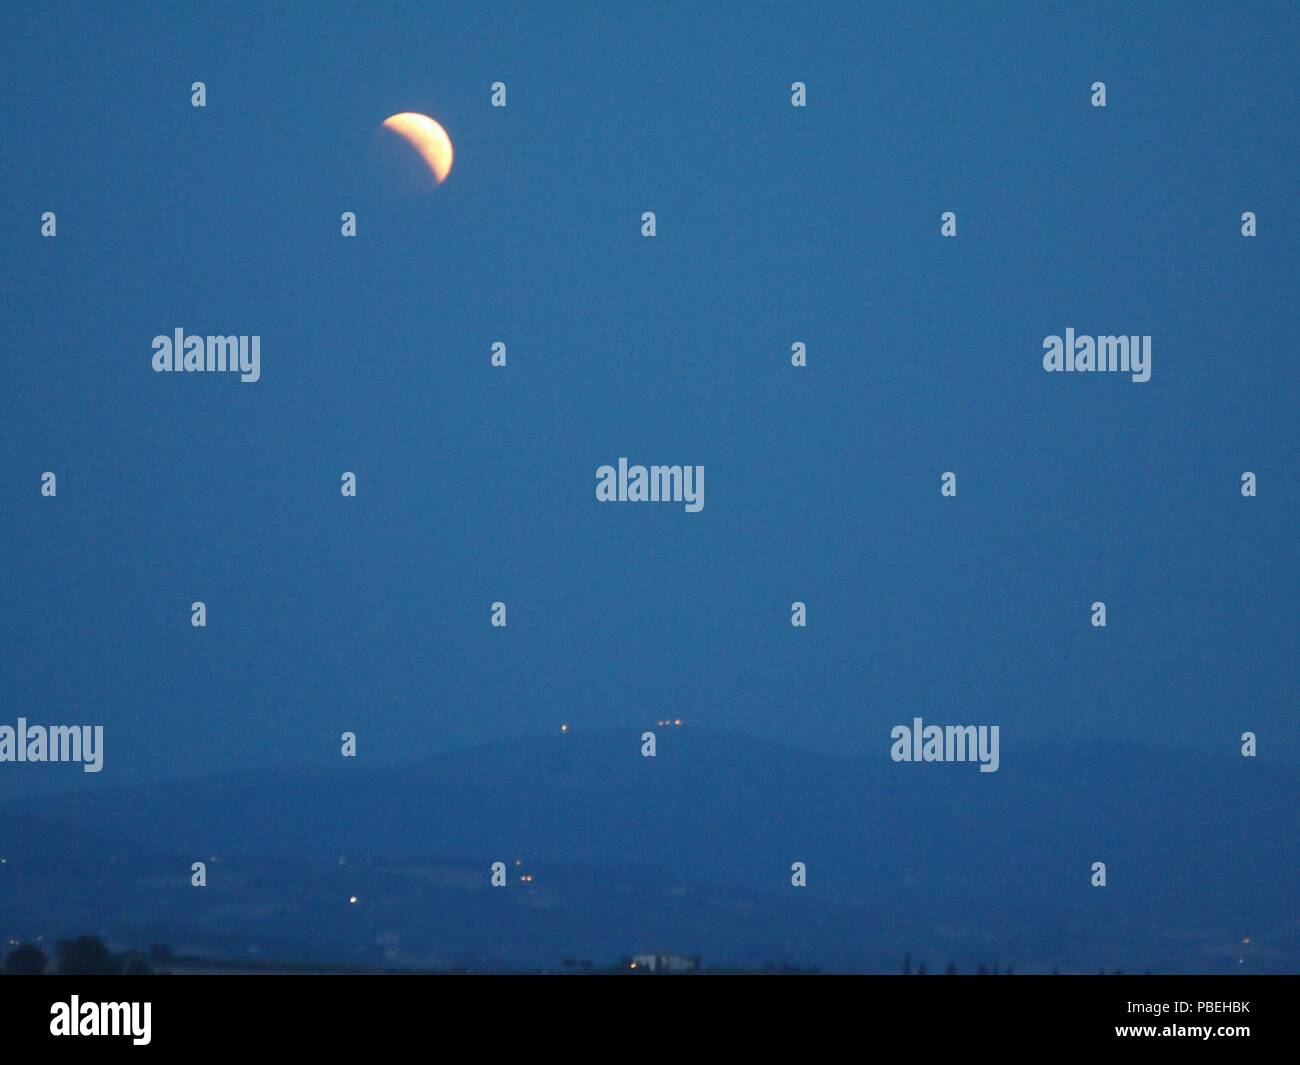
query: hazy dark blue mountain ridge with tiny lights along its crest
0 726 1300 969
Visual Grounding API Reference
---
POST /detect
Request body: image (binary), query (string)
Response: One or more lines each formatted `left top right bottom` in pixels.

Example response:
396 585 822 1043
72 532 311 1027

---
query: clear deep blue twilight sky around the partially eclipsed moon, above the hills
0 3 1300 793
